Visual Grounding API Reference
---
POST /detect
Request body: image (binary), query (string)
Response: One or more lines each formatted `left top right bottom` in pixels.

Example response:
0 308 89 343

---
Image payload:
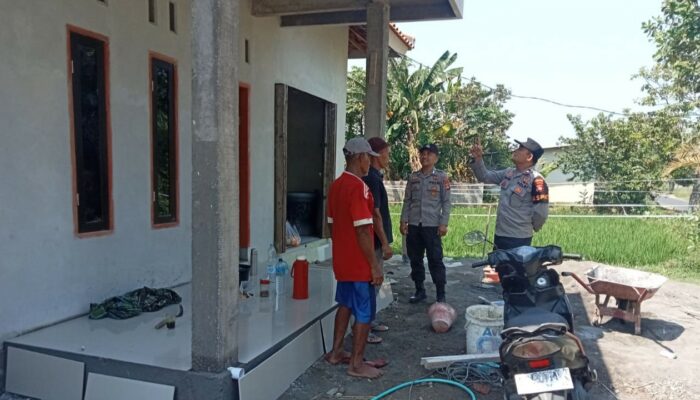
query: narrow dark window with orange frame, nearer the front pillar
150 55 178 227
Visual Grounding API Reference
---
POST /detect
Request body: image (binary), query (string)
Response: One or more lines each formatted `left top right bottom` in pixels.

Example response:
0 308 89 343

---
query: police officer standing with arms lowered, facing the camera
401 144 452 303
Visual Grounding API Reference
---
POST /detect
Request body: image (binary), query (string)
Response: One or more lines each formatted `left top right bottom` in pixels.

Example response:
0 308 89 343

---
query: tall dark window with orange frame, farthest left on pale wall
68 27 112 234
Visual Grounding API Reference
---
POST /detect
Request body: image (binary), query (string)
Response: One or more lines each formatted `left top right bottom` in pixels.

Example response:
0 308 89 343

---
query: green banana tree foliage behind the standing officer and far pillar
346 52 513 180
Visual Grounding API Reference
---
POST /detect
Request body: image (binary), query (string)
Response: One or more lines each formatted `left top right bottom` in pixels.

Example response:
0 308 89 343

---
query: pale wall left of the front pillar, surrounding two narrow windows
0 0 191 342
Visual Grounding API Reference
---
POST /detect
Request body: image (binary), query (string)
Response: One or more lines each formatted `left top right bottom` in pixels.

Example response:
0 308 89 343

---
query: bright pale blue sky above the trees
366 0 661 146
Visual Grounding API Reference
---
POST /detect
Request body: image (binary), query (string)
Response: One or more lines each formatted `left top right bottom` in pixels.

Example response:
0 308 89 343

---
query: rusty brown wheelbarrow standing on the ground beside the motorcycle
562 265 666 335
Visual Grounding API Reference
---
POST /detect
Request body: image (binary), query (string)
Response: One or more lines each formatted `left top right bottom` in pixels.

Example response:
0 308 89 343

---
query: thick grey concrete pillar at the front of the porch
192 0 240 372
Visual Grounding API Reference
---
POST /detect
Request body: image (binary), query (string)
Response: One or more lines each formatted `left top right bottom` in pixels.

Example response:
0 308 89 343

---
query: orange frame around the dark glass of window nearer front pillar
148 51 180 229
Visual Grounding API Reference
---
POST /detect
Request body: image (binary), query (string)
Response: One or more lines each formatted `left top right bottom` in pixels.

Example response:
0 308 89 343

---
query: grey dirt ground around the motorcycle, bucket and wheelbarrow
280 256 700 400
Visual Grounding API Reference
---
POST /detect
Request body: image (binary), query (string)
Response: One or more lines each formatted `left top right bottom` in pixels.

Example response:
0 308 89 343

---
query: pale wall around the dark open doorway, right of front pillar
240 1 348 256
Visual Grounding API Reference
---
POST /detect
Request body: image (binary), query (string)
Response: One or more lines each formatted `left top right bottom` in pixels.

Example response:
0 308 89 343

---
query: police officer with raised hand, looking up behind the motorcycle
471 138 549 249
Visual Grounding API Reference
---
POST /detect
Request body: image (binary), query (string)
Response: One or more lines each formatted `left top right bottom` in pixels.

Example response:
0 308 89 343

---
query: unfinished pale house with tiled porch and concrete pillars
0 0 462 400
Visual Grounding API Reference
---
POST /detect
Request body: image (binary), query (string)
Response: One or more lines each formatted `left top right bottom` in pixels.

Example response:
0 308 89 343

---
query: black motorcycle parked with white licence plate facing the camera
464 231 597 400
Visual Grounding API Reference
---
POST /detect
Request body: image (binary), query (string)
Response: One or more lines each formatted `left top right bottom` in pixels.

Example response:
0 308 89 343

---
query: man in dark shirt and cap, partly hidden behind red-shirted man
362 137 394 343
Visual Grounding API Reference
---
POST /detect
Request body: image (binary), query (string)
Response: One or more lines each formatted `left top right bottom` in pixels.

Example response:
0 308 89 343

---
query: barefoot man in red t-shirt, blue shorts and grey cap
326 137 386 378
